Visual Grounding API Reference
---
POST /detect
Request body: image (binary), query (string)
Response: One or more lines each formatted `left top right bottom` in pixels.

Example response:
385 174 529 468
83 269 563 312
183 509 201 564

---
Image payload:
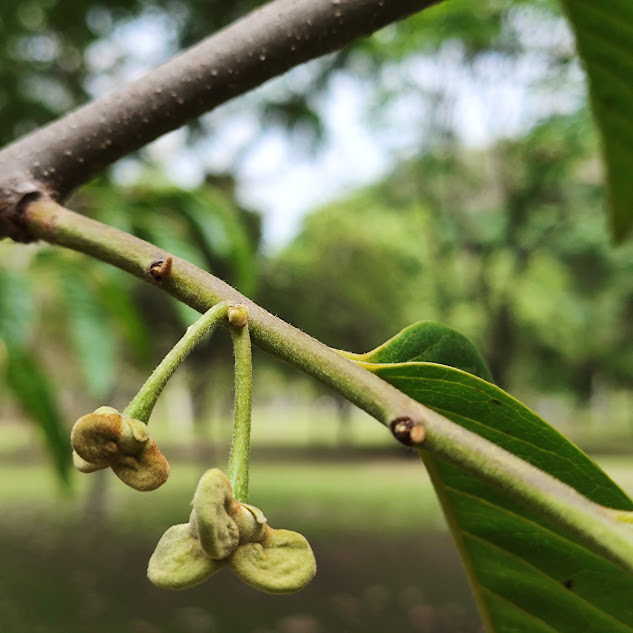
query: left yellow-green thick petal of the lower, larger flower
147 523 225 589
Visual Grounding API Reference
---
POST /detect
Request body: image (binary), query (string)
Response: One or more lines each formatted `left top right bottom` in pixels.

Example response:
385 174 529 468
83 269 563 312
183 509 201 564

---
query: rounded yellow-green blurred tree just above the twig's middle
260 195 431 350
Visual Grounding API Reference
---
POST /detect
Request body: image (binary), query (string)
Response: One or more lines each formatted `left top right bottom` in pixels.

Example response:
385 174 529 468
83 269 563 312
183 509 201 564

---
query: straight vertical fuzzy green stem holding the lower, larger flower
228 306 253 503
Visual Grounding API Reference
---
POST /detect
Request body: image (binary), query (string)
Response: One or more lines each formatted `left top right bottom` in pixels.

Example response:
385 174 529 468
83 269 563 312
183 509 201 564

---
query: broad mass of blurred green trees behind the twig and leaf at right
261 111 633 400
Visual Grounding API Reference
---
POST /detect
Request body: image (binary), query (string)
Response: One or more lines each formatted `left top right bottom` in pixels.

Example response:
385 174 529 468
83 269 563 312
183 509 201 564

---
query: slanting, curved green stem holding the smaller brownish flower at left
123 303 228 423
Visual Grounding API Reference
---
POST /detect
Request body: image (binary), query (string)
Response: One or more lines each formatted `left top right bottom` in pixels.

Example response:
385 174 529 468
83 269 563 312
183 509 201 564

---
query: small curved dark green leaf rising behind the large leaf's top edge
347 321 493 382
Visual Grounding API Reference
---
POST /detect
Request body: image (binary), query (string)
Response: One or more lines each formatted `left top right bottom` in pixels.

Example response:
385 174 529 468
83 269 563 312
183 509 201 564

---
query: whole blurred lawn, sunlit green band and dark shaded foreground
0 404 633 633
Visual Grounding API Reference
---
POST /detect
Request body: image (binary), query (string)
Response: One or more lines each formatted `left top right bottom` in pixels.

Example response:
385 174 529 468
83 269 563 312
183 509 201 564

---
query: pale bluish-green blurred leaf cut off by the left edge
0 270 34 347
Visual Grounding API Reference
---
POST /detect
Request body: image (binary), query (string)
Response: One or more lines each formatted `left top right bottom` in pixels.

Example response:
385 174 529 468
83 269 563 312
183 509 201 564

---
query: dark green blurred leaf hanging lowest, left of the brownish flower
6 345 71 486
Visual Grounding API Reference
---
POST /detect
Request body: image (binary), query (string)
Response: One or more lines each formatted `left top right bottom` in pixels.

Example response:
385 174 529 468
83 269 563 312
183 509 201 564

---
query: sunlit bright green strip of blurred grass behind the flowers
0 458 443 535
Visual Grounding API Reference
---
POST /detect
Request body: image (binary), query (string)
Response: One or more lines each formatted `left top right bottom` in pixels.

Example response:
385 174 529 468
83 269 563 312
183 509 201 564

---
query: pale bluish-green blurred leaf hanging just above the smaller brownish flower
58 262 117 398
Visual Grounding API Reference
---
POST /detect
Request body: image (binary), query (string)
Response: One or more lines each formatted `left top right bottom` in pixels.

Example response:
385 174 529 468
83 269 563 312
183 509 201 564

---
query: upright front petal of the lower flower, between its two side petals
192 468 240 560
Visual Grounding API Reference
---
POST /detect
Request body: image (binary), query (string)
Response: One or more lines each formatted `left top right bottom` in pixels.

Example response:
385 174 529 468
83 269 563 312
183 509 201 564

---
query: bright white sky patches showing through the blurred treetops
86 9 586 252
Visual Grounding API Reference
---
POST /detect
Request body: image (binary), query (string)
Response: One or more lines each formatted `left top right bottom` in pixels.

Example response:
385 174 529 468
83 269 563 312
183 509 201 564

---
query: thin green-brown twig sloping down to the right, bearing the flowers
22 198 633 572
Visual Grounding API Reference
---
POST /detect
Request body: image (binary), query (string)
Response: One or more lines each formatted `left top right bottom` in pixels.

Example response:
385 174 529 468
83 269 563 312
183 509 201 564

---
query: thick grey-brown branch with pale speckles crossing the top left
0 0 438 228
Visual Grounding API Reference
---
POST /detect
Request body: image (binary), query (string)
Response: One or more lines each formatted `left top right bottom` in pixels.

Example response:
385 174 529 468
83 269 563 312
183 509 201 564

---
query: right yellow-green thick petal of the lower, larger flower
228 528 316 593
